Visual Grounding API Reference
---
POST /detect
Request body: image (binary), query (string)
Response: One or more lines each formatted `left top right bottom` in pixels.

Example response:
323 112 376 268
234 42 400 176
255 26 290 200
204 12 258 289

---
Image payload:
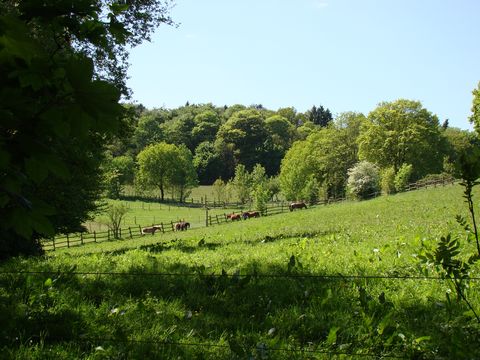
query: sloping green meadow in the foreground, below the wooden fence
0 185 480 359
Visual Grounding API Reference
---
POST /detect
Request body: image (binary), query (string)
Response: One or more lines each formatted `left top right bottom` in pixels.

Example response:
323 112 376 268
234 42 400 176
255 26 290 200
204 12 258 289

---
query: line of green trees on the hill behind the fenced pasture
105 97 479 205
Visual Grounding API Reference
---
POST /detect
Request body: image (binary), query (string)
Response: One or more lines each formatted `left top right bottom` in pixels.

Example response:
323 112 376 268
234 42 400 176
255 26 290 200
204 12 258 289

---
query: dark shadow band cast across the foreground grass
0 258 480 359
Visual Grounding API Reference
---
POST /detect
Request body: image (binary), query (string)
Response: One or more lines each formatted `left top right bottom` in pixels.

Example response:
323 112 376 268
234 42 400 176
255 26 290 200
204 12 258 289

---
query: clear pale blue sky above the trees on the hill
128 0 480 129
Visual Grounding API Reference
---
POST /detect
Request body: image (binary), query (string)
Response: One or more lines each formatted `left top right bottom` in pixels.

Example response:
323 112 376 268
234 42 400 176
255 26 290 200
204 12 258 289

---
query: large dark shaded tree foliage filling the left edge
0 0 170 258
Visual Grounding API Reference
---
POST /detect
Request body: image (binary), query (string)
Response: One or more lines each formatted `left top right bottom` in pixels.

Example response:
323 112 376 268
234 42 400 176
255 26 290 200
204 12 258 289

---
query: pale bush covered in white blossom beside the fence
347 161 380 199
